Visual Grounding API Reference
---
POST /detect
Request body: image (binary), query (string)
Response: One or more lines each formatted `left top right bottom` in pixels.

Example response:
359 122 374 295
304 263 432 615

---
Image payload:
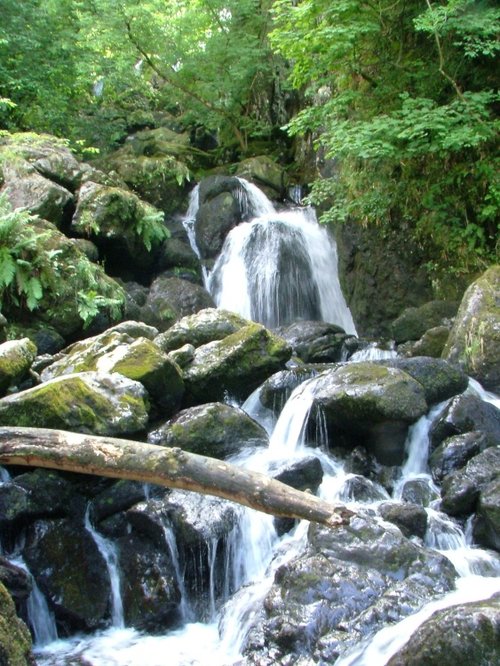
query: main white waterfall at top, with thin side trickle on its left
184 179 356 334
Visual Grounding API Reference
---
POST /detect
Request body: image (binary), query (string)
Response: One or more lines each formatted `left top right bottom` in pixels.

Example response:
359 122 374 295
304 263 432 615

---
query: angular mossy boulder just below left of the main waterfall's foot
184 323 290 404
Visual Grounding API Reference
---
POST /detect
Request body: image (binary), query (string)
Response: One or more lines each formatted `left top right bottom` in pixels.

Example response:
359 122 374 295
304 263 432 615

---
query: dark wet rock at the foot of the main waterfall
277 321 351 363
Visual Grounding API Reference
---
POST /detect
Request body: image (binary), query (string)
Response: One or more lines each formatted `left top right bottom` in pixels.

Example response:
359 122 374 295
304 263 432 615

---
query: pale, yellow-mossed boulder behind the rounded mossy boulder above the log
41 323 184 416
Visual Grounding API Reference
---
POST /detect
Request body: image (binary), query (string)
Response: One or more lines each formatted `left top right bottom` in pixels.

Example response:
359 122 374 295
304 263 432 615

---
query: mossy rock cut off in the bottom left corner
0 583 34 666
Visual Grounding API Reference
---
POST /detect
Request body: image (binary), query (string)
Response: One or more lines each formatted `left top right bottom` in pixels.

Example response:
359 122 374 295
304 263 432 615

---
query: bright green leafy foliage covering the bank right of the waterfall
272 0 500 278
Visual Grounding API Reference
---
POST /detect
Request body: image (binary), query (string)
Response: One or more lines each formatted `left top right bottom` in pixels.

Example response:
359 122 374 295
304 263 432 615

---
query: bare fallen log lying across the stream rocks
0 427 353 527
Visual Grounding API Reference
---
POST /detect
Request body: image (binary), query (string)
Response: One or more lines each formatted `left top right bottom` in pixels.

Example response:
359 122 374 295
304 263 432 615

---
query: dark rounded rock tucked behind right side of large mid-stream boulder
380 356 469 405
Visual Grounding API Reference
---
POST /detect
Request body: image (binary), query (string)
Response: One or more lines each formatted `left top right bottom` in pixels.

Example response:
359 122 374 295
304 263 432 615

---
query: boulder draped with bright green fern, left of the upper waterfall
71 181 168 275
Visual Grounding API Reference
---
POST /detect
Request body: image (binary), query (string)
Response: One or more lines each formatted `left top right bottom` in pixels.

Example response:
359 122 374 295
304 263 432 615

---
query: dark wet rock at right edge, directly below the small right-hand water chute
429 394 500 448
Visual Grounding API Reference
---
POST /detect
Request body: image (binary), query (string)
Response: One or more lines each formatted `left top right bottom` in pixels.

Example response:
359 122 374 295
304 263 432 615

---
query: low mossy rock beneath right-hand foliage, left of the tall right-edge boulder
391 301 458 342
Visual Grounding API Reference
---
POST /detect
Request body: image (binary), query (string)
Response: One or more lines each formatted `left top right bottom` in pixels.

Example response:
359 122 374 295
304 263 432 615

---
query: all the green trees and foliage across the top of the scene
0 0 500 286
